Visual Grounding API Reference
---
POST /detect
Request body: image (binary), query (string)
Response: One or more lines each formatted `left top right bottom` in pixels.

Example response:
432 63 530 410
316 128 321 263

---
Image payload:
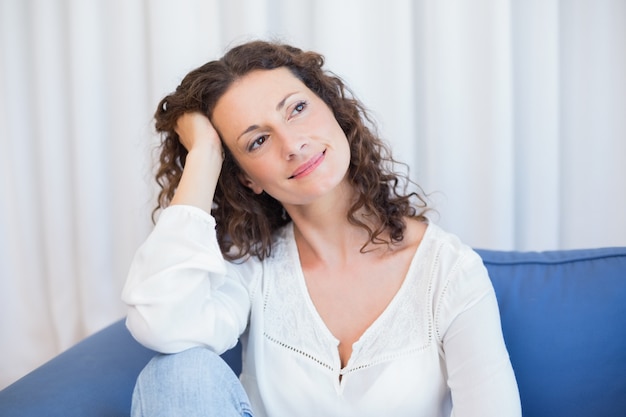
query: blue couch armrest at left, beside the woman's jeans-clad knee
0 320 154 417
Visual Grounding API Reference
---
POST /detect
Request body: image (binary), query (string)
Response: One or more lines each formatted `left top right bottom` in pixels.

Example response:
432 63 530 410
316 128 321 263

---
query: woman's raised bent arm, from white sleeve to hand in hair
122 113 255 353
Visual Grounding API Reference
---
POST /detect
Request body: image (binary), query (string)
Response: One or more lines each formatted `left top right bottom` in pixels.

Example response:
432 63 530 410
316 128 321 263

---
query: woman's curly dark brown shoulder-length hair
153 41 428 260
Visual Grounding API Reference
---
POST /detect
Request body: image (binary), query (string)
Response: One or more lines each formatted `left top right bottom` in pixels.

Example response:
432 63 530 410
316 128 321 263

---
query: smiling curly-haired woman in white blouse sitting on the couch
123 41 521 417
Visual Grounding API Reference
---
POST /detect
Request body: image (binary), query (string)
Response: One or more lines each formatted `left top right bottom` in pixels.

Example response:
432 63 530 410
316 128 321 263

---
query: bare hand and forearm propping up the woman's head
171 112 224 213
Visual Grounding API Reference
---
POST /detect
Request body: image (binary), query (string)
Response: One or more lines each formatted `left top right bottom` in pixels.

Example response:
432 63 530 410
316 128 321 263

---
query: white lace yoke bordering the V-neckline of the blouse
264 226 435 375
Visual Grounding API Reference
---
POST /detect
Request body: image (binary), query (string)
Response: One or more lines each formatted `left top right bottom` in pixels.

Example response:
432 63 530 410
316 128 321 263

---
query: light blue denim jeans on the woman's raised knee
131 348 252 417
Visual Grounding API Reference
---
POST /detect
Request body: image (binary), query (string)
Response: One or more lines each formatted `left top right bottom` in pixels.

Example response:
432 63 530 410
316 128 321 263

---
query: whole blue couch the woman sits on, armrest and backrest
0 248 626 417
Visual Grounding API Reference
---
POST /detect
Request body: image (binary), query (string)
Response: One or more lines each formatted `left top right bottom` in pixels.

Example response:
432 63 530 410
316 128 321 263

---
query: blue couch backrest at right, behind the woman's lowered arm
478 248 626 417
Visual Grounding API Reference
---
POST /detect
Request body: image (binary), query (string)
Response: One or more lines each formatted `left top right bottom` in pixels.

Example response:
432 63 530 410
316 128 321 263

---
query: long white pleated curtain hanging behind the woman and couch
0 0 626 387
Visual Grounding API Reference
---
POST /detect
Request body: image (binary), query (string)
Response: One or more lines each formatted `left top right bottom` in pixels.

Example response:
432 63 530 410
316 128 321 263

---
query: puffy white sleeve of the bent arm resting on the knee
122 206 254 353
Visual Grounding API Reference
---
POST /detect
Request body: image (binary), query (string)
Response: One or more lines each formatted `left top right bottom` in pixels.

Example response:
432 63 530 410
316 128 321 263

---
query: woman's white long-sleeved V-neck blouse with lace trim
122 206 521 417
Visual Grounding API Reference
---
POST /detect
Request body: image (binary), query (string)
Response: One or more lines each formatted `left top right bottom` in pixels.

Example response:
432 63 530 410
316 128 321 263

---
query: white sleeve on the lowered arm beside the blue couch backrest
437 254 521 417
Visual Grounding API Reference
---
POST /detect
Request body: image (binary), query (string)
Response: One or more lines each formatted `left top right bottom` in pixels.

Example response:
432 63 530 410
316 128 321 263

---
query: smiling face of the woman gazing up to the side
212 67 350 206
